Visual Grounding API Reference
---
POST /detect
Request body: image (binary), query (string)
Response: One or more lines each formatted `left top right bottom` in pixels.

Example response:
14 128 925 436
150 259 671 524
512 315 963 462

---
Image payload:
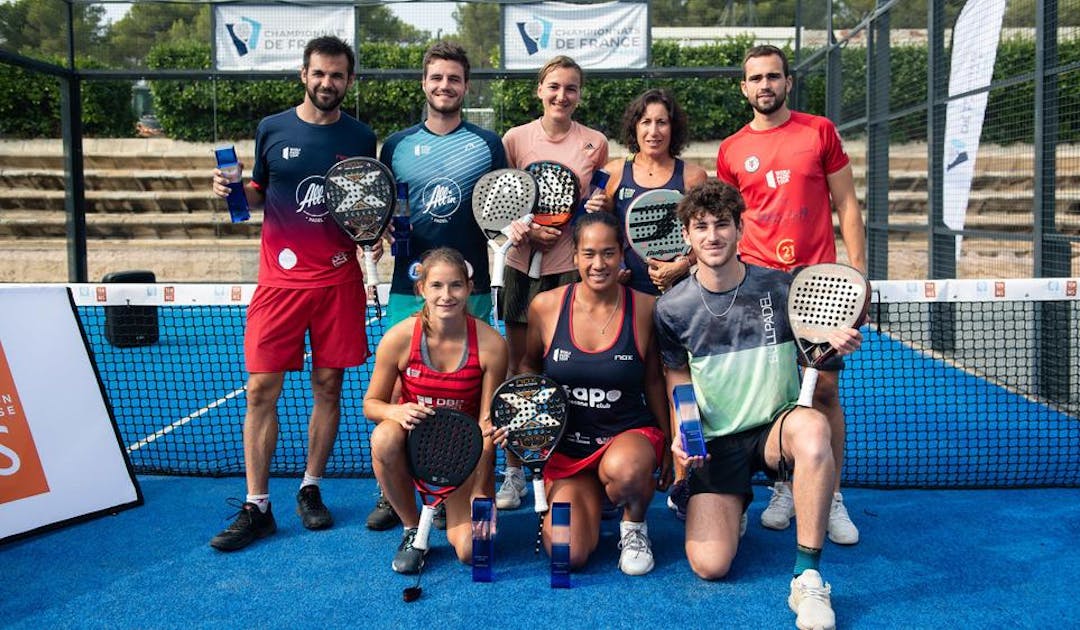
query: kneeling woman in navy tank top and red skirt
522 212 671 575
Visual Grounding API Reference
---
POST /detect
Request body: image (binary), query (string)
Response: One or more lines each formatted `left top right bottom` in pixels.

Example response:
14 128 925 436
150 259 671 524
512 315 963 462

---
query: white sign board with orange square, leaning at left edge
0 285 143 542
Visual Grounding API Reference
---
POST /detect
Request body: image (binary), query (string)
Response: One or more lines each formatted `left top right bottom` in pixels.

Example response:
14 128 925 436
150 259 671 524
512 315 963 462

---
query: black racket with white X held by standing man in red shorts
323 158 397 286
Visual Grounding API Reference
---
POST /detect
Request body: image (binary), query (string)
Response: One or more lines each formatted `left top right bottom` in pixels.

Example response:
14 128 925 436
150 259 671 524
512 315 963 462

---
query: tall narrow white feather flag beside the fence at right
942 0 1007 258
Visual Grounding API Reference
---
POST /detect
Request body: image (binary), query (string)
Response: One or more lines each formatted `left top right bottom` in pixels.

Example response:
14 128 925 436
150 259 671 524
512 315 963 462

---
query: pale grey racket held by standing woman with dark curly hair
624 188 689 263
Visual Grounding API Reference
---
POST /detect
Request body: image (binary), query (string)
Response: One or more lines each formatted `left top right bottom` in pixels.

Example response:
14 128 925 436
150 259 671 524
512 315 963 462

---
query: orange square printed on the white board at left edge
0 345 49 505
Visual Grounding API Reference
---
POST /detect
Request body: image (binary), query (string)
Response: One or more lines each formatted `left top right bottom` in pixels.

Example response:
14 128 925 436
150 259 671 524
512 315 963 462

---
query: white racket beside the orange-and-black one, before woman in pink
472 169 539 291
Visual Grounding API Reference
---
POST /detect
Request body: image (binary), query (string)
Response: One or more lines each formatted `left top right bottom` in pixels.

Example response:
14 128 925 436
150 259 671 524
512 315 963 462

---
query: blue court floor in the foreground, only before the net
0 477 1080 629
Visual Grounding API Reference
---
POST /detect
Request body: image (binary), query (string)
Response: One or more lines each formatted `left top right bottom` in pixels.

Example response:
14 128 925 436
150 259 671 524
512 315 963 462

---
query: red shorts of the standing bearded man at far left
244 281 368 373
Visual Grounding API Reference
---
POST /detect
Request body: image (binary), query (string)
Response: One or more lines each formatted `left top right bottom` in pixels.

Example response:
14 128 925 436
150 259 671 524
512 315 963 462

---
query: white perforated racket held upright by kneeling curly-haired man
787 263 870 407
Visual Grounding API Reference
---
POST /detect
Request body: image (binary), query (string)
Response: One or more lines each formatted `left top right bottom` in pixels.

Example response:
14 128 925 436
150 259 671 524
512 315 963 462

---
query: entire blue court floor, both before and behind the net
0 293 1080 629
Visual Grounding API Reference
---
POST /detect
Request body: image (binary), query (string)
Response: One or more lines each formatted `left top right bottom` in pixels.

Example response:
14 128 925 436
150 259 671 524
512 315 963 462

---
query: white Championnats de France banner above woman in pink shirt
502 2 649 70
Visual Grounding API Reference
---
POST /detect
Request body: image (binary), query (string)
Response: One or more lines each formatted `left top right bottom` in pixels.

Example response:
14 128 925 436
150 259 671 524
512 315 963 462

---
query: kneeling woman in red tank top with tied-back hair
364 247 508 573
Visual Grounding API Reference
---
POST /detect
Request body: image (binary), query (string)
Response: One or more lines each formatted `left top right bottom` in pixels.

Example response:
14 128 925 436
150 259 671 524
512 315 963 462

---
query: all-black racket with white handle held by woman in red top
406 407 484 550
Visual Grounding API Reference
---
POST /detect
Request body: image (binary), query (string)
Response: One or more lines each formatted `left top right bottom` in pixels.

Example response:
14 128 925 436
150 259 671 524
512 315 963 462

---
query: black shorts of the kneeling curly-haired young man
687 407 795 510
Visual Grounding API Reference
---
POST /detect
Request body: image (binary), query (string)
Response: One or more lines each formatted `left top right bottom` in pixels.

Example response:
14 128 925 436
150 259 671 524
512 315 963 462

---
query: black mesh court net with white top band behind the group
70 279 1080 487
